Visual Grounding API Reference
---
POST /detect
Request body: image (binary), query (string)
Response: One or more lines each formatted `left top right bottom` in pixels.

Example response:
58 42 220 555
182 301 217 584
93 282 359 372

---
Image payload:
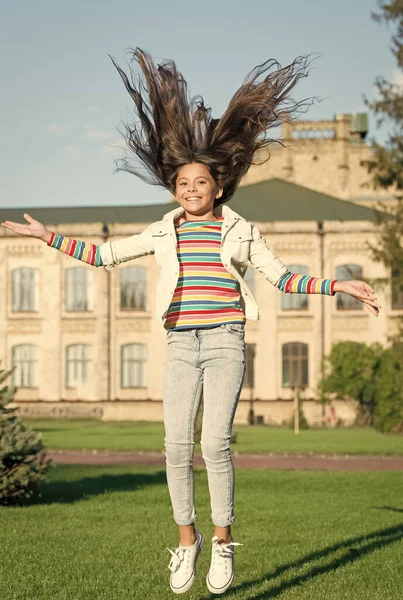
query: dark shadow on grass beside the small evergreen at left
29 471 166 505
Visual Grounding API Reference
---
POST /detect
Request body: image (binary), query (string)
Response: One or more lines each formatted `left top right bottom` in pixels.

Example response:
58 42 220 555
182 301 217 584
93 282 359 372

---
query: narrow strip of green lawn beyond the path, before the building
26 419 403 454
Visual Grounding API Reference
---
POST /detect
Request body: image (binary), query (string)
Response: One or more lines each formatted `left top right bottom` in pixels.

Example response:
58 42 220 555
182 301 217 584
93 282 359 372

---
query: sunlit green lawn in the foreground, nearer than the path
0 464 403 600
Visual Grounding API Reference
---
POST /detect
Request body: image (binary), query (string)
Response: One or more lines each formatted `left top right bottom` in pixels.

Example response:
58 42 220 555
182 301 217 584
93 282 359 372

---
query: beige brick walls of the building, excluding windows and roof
0 116 403 424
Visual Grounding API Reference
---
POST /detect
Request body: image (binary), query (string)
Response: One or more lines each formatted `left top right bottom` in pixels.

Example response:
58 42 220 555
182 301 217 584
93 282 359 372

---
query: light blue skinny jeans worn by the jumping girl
163 324 245 527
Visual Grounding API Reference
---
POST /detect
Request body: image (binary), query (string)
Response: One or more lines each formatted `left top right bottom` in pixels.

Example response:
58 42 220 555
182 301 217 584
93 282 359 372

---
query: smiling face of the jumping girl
175 163 223 221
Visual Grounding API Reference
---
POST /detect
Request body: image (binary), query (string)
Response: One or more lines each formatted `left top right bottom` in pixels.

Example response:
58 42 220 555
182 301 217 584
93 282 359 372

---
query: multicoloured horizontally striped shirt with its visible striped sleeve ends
48 227 336 330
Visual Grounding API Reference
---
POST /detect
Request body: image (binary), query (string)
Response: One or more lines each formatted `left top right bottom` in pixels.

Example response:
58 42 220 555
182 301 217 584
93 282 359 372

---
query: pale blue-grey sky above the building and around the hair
0 0 402 210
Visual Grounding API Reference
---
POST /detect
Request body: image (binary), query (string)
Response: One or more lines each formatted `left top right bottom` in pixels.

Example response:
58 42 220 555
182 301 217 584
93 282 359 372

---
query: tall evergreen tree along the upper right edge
365 0 403 343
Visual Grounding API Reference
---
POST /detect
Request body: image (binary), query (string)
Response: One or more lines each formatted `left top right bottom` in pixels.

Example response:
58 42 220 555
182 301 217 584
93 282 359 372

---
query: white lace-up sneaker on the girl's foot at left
167 531 204 594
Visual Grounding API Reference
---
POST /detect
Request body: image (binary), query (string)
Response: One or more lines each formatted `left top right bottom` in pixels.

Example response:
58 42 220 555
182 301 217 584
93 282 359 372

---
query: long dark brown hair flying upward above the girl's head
111 48 316 204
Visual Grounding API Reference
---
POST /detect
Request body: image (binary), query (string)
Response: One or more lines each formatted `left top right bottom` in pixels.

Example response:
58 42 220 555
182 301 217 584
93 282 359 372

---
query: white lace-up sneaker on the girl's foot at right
206 535 242 594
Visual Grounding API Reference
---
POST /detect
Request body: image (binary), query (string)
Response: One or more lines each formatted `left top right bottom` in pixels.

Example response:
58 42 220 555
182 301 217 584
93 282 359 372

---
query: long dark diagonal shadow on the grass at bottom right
201 523 403 600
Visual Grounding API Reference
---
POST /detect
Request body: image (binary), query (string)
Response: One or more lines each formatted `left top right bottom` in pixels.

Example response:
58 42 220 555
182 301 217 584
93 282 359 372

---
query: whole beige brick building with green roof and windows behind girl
0 117 403 424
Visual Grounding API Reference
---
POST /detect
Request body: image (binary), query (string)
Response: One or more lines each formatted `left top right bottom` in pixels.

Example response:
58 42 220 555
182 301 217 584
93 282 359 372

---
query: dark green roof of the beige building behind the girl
0 179 375 225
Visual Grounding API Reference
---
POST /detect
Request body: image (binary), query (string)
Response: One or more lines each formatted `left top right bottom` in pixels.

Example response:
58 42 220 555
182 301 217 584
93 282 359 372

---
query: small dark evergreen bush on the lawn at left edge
0 369 51 505
